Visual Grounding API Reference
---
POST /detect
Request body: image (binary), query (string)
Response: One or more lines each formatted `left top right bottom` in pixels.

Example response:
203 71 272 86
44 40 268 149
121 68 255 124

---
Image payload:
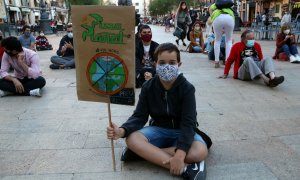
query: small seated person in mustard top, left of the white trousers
189 21 204 53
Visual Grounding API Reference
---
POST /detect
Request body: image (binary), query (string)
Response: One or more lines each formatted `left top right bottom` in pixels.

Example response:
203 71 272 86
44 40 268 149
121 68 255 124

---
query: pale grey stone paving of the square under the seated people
0 26 300 180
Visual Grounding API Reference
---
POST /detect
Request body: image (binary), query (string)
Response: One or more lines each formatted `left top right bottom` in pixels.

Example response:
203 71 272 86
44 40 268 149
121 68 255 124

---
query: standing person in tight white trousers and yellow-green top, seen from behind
209 3 234 68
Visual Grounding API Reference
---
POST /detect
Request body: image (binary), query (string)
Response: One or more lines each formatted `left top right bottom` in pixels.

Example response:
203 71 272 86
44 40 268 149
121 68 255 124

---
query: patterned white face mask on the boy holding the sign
156 64 178 81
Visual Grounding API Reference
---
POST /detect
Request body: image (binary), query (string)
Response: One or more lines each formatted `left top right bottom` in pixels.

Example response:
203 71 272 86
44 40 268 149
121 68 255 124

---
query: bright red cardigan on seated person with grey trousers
224 42 263 79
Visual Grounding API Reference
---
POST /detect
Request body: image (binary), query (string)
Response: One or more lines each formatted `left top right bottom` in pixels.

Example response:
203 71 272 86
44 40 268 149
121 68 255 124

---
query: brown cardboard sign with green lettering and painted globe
72 6 135 105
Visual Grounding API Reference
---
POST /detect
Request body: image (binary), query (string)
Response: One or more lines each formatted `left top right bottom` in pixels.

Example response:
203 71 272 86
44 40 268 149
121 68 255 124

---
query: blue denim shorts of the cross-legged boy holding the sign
139 126 206 148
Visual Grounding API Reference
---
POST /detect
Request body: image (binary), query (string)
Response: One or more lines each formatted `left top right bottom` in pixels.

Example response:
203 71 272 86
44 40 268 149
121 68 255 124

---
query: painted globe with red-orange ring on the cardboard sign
86 53 128 95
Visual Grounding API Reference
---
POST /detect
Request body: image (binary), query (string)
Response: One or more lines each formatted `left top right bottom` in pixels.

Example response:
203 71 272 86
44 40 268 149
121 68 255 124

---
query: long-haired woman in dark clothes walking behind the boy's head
175 1 192 46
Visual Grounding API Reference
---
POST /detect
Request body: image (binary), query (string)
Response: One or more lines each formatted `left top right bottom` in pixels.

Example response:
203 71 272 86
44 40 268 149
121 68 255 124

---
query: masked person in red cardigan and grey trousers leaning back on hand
220 30 284 87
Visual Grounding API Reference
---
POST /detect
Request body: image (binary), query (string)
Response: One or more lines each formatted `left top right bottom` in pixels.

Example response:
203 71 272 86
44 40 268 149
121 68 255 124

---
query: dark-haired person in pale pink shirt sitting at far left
0 37 46 97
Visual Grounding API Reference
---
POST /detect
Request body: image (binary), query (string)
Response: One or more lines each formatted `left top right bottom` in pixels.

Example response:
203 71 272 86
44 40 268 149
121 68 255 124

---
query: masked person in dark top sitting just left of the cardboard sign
49 25 75 69
